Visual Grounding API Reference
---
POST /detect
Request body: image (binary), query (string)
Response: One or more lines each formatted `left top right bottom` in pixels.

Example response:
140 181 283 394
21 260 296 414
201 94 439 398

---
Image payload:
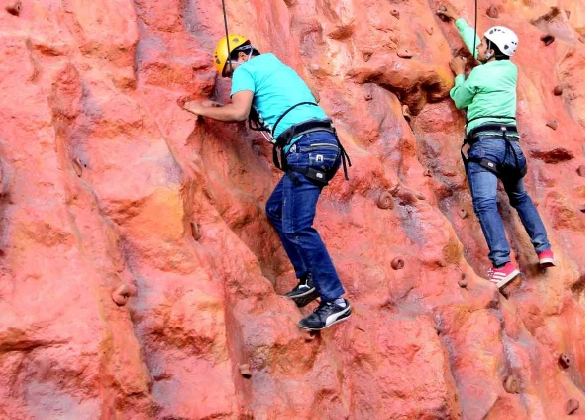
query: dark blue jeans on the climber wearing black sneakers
266 131 345 302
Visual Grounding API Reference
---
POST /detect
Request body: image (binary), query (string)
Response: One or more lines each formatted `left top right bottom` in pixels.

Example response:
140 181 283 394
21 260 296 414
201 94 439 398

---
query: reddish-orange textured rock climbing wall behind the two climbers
0 0 585 420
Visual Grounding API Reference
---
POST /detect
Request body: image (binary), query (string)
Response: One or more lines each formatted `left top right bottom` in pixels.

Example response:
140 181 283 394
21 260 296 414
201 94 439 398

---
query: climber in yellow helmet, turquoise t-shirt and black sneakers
182 35 351 330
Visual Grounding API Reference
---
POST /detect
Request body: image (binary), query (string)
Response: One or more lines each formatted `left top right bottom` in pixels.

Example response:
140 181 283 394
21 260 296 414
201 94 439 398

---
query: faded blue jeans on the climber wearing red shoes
467 136 550 267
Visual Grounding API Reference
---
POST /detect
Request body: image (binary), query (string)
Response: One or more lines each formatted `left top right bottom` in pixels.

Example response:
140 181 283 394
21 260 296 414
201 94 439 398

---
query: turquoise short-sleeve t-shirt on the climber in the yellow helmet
231 54 328 145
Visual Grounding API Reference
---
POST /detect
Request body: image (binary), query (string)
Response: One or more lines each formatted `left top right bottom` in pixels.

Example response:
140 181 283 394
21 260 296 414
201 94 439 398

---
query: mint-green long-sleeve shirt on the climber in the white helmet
450 19 518 132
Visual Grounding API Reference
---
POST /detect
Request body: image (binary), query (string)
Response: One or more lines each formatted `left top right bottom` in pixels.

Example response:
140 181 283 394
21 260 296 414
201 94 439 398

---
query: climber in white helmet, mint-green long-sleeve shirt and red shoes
437 5 556 290
